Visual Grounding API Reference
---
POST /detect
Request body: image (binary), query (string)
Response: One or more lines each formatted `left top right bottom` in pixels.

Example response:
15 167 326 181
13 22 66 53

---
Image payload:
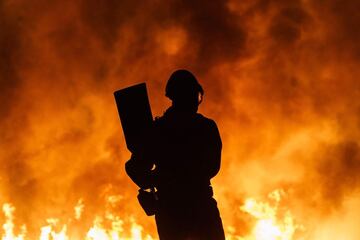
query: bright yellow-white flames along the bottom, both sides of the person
2 190 304 240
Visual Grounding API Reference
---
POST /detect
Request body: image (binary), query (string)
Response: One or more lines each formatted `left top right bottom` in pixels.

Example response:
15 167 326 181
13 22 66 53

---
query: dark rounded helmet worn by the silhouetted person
165 69 204 104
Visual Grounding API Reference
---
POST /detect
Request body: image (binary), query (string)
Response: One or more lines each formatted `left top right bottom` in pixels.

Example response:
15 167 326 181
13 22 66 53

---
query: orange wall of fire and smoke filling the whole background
0 0 360 240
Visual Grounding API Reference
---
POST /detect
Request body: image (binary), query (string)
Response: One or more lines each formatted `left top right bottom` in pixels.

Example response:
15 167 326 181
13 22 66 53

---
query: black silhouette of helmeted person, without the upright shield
126 70 225 240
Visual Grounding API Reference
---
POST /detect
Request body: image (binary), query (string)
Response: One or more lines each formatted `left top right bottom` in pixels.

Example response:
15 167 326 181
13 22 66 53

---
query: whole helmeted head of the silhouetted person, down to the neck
165 69 204 112
